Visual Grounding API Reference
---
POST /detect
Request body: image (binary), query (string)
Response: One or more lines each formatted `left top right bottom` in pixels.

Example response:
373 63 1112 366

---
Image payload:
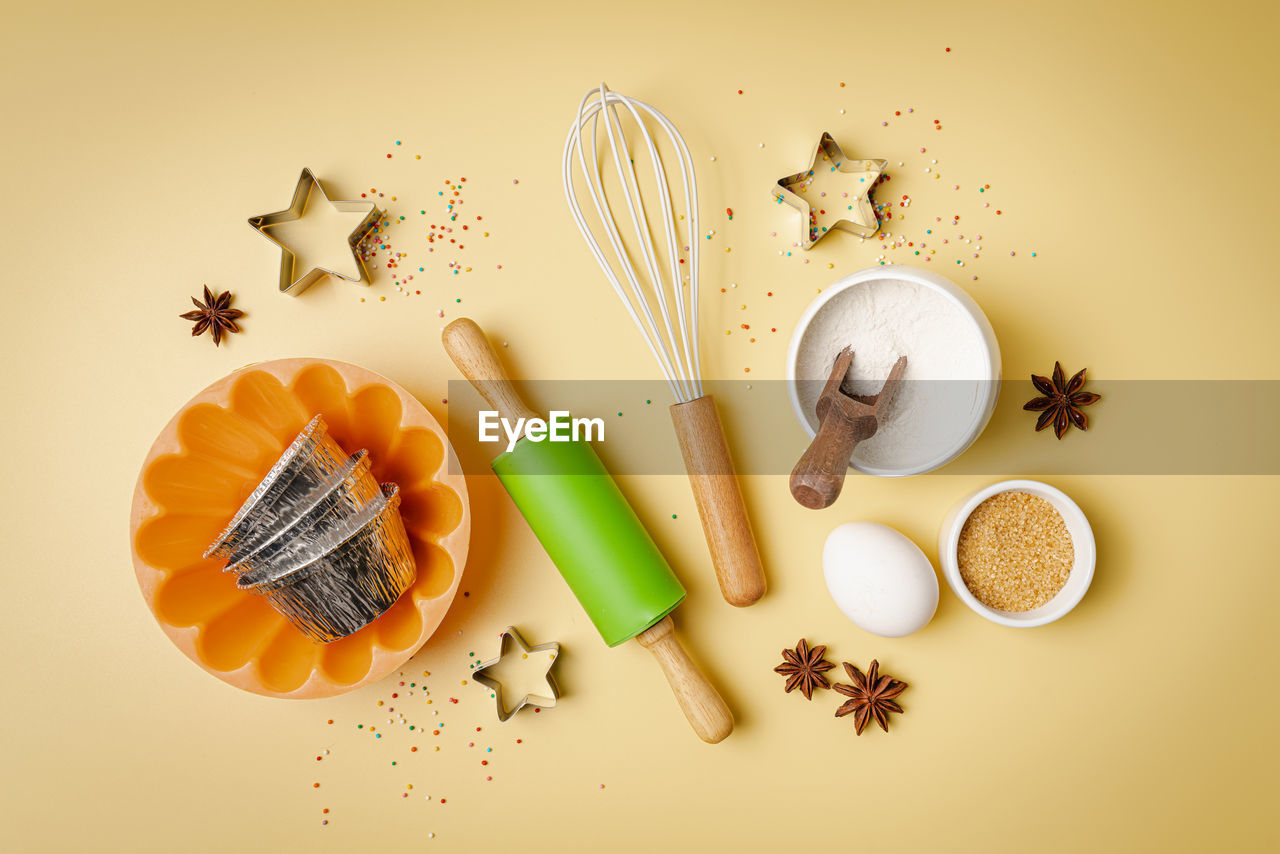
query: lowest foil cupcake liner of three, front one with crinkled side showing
236 484 417 643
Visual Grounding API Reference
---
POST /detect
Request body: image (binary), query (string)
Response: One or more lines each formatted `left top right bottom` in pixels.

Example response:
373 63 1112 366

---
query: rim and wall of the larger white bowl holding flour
786 264 1001 478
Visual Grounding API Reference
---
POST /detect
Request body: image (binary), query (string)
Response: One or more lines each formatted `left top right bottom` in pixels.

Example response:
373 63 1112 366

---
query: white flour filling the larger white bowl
796 279 989 469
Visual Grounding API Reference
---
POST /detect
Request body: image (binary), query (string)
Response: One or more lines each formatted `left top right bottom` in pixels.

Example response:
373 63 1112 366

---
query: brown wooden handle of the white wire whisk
671 394 765 607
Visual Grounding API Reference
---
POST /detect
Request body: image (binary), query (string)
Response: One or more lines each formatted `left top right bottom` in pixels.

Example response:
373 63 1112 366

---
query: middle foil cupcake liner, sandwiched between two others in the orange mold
224 451 385 577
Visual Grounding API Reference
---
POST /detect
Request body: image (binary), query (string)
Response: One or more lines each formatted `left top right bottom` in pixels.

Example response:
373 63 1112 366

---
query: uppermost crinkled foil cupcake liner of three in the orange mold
205 415 347 562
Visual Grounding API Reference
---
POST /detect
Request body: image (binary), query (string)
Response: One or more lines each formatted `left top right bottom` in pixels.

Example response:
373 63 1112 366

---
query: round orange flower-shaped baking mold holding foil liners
129 359 471 698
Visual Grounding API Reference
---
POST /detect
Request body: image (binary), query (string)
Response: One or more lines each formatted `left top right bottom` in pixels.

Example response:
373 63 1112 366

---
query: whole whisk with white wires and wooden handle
562 83 764 606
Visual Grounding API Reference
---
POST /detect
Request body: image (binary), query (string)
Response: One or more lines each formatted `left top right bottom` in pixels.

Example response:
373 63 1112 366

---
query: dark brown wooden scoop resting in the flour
791 347 906 510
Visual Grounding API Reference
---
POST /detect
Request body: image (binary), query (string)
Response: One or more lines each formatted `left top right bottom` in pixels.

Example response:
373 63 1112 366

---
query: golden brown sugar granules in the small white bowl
956 492 1075 611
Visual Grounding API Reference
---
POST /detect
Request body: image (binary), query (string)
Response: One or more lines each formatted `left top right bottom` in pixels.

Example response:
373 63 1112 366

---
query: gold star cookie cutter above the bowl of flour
773 133 888 250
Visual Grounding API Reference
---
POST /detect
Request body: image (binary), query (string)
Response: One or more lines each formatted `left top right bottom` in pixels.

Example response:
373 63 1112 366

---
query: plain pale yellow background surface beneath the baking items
0 1 1280 851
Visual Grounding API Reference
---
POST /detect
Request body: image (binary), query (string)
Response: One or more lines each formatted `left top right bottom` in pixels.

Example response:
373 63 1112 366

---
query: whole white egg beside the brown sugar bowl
822 522 938 638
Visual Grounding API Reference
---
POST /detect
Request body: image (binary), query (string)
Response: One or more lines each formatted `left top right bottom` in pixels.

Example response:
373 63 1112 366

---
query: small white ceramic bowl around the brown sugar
938 480 1097 629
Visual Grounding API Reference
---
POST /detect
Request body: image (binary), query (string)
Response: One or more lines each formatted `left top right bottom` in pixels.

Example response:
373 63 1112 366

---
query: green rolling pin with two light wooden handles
443 318 733 744
